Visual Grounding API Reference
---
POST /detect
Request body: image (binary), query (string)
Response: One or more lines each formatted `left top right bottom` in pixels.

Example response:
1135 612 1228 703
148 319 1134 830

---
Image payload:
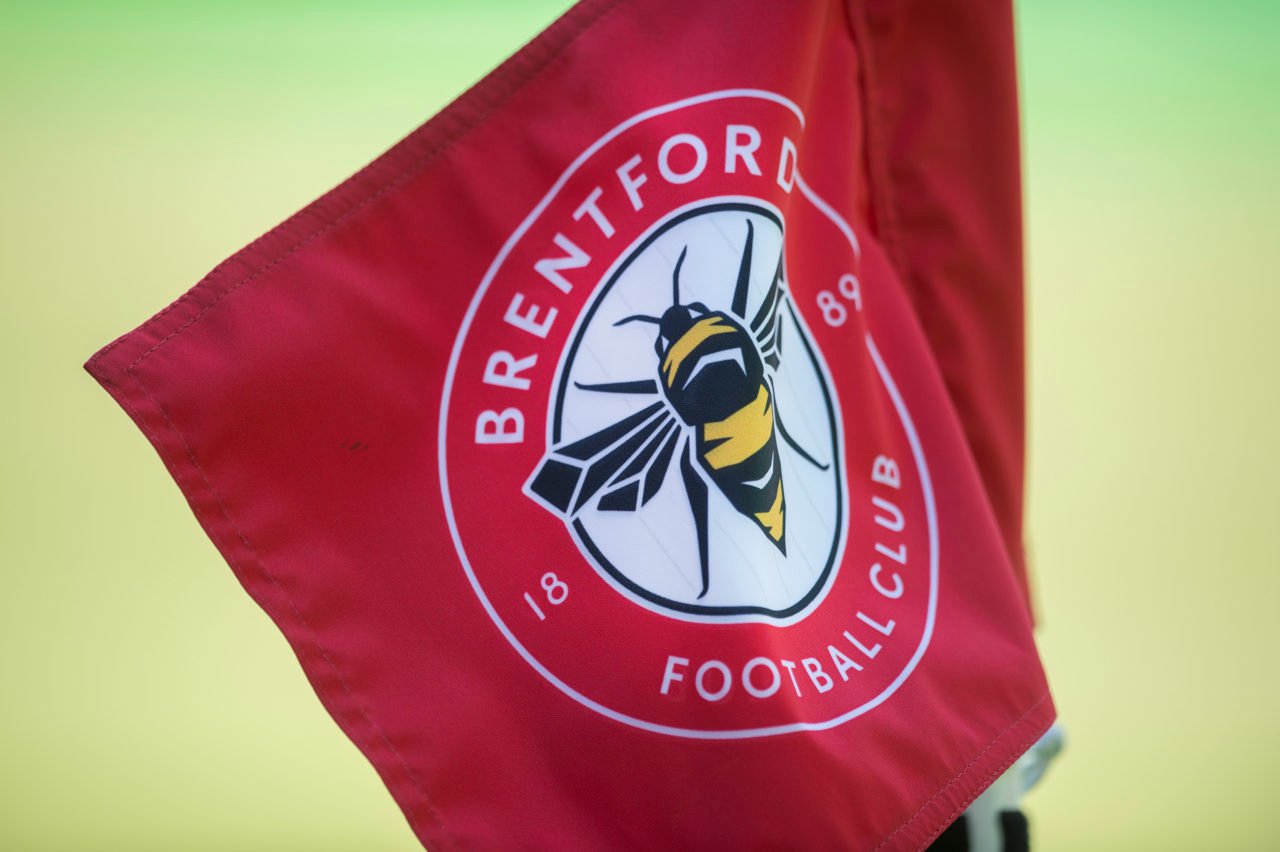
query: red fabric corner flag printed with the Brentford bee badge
87 0 1053 849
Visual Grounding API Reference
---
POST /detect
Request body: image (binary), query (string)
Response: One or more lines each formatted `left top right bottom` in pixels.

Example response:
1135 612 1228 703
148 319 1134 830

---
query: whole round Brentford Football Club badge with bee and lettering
440 90 937 737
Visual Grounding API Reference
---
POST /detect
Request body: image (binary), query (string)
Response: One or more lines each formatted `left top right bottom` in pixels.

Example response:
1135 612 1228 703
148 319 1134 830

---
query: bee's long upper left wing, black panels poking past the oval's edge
529 403 675 518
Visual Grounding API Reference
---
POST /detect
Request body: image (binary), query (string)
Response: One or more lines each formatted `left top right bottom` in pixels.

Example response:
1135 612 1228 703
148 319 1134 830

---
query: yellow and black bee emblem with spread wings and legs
529 220 828 599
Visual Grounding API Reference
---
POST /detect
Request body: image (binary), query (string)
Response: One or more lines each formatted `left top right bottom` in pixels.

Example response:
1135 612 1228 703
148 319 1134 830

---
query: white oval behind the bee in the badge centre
552 198 842 620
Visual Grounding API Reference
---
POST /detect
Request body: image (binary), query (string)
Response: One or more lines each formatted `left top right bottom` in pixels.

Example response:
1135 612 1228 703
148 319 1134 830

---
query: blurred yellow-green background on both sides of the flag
0 0 1280 852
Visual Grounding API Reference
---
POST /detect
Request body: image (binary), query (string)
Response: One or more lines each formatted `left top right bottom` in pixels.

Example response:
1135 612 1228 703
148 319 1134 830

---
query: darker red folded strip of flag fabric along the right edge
854 0 1028 603
